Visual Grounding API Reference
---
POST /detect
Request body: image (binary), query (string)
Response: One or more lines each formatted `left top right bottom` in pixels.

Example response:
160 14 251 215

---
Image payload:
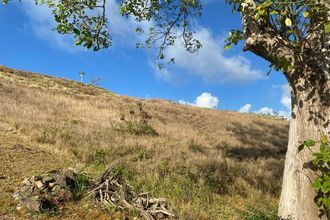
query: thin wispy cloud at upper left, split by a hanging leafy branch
22 0 151 52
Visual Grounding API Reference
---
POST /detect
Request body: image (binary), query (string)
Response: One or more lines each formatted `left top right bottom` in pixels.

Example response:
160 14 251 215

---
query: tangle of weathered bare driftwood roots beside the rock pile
88 164 175 220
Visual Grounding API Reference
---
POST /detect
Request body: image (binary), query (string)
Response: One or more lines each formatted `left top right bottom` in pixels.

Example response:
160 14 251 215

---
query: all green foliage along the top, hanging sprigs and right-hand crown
2 0 330 64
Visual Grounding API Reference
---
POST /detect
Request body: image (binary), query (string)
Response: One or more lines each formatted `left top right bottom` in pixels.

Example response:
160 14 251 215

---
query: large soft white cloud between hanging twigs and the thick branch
161 28 262 83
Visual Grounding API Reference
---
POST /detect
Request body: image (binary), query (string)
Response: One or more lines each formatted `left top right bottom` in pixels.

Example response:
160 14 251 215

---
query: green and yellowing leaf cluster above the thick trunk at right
225 0 330 72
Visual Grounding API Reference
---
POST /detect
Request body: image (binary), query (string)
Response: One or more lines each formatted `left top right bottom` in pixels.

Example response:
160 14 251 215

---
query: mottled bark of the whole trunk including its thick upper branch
241 0 330 220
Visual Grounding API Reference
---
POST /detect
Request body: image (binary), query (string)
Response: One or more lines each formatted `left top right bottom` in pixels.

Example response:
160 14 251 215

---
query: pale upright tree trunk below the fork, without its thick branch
278 80 330 220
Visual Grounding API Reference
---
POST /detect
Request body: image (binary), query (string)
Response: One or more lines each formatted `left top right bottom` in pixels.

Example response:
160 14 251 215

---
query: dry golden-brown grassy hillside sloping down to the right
0 67 288 219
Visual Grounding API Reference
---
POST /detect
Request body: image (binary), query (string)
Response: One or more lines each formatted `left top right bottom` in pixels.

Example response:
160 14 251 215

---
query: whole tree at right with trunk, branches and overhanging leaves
2 0 330 220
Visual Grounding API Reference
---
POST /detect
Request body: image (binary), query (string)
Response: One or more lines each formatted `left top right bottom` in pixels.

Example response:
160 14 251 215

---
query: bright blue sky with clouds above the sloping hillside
0 0 290 117
